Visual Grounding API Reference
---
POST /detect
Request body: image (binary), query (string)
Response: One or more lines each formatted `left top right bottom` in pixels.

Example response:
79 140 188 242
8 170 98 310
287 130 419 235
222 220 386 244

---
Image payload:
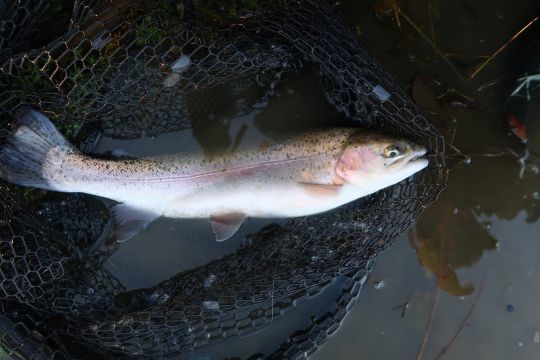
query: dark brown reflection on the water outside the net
341 1 540 296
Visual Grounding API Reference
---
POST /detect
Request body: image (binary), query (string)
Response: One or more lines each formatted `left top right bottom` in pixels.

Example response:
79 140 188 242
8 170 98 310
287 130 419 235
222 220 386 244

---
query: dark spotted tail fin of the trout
0 109 74 190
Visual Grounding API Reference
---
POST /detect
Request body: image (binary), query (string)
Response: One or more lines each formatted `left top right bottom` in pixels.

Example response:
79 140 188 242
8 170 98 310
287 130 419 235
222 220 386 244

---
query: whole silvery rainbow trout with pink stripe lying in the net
0 110 428 241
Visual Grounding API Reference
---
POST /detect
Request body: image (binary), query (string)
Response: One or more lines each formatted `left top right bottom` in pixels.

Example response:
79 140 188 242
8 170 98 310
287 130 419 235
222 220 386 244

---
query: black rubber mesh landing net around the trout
0 0 446 359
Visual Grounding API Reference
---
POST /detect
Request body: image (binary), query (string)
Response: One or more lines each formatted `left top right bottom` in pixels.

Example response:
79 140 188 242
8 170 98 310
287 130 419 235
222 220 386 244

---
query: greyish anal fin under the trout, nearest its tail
111 204 159 242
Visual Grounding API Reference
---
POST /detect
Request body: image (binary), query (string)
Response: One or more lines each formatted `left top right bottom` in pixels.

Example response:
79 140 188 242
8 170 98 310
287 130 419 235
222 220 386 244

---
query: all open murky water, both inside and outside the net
93 0 540 359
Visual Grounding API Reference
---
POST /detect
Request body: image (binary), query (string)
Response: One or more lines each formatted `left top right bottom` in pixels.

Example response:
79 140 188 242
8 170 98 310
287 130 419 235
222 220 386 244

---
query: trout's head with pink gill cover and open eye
336 132 428 194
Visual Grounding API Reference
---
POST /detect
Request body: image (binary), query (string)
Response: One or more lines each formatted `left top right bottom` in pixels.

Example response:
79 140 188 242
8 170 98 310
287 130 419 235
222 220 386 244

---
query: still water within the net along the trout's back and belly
95 70 341 290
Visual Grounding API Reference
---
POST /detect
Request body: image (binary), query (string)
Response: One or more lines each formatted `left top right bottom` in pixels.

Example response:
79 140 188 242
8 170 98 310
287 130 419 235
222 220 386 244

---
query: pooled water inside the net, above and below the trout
96 69 341 289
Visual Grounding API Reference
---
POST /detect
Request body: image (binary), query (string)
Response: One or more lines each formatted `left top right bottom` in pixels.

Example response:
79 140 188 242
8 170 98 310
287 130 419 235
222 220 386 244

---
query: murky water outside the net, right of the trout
313 1 540 360
